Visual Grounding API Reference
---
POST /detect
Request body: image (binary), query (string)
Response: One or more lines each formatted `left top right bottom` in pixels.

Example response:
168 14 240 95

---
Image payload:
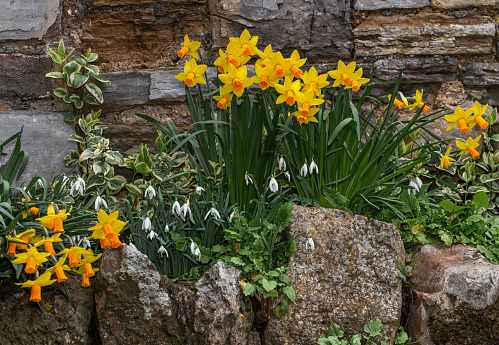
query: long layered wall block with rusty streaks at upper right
353 13 495 56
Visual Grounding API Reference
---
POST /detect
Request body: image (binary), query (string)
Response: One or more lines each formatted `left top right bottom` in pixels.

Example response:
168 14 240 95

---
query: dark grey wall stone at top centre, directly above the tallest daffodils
209 0 353 62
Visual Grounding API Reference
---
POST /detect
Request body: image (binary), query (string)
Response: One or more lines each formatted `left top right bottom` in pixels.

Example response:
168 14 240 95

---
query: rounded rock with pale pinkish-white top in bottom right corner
406 245 499 345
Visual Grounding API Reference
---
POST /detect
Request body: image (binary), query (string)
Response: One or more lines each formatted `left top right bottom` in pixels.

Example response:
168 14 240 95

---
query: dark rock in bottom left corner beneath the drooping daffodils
0 275 93 345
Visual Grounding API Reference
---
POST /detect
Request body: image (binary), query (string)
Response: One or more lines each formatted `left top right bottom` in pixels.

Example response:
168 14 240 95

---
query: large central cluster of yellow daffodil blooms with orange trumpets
176 30 369 124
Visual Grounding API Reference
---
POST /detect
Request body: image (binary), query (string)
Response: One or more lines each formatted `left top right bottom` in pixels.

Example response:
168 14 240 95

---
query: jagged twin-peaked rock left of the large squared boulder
95 245 259 345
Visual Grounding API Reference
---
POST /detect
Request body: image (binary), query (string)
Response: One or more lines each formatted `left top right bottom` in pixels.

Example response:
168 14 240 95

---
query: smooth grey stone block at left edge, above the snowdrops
0 110 77 182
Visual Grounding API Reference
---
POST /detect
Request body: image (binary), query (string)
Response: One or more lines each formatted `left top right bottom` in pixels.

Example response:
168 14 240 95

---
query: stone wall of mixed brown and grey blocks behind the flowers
0 0 499 180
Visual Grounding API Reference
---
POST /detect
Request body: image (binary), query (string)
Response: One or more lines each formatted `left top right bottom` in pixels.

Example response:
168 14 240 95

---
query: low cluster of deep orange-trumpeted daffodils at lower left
5 205 126 302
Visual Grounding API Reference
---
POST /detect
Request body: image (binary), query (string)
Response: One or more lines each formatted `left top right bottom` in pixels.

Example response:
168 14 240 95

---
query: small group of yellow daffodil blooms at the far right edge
440 102 489 169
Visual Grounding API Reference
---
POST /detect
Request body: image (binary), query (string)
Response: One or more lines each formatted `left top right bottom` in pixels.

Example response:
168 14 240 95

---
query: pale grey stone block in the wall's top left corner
0 0 59 42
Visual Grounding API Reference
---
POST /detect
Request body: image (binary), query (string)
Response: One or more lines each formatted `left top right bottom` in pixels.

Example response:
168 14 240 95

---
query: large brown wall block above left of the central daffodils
82 0 211 71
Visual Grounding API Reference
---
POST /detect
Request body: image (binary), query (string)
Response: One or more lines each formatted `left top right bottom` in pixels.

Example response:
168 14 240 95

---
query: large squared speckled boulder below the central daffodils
267 206 404 345
